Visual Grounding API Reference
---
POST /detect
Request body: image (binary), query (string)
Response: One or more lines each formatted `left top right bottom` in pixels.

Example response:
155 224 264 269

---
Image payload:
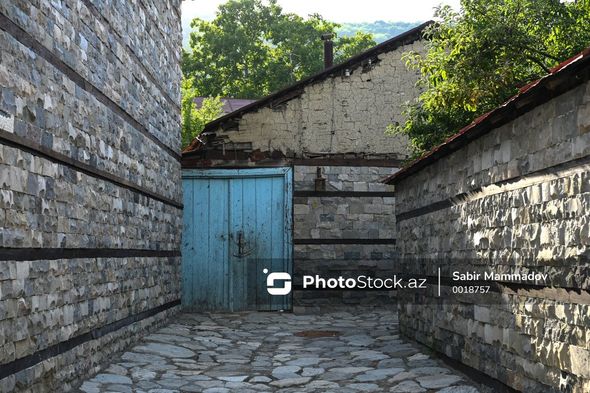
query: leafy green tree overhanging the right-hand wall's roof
388 0 590 156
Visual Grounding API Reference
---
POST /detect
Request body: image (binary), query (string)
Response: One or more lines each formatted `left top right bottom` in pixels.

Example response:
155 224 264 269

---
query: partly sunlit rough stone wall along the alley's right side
396 83 590 393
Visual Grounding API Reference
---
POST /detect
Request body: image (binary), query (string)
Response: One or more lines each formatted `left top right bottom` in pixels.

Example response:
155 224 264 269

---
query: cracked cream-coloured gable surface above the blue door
207 40 424 159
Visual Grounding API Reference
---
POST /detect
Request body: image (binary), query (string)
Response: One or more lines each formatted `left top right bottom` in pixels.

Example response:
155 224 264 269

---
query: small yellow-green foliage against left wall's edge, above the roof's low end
180 78 223 148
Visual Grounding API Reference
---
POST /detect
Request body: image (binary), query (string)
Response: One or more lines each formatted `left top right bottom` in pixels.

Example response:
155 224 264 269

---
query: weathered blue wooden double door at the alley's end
182 168 293 311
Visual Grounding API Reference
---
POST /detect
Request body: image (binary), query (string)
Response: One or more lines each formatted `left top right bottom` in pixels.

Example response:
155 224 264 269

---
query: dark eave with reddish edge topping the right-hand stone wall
382 47 590 184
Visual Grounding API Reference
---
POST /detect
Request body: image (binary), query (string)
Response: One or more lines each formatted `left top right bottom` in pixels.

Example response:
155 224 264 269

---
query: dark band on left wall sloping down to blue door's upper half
0 130 183 209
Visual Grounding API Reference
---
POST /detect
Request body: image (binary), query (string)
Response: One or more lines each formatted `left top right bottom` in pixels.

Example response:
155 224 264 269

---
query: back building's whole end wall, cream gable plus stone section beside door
183 32 424 311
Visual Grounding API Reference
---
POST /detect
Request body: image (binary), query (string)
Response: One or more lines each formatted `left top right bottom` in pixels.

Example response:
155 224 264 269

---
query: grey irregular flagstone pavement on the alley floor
80 311 486 393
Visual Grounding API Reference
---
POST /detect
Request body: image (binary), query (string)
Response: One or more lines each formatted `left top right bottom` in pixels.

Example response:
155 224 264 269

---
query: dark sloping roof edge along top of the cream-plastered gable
183 21 434 153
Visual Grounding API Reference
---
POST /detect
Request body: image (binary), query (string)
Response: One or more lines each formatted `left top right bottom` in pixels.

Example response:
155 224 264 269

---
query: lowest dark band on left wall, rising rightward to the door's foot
0 300 180 379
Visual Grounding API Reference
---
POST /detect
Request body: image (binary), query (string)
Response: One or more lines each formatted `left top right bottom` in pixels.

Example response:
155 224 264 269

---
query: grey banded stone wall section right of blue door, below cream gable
293 166 395 310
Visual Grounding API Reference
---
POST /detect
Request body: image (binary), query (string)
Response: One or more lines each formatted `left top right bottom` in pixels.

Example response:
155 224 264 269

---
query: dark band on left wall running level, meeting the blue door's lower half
0 247 180 261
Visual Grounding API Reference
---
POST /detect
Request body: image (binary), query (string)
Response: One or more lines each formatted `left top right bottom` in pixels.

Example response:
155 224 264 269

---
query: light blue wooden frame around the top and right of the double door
182 166 293 305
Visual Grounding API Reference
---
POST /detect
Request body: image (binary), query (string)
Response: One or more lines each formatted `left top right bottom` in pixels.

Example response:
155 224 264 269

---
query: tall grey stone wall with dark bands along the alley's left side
0 0 182 392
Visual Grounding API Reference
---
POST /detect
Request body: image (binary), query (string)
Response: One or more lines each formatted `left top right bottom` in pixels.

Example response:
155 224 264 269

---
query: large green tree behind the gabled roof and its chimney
182 0 375 98
